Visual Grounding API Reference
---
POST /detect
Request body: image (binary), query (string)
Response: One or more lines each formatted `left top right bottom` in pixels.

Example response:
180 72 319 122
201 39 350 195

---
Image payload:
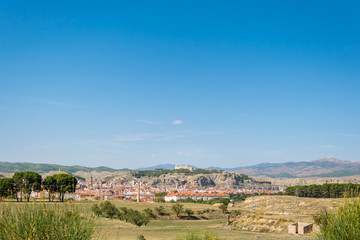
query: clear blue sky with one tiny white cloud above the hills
0 0 360 168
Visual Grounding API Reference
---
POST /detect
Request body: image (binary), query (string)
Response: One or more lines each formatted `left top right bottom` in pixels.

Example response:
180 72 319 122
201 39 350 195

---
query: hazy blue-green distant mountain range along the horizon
0 158 360 178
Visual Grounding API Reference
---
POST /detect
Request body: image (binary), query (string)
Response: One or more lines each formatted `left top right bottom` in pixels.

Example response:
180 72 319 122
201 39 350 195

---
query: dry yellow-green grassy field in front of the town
0 196 343 240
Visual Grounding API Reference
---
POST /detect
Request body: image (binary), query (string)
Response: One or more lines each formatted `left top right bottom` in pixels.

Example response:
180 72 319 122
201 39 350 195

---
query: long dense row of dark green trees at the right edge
285 183 360 198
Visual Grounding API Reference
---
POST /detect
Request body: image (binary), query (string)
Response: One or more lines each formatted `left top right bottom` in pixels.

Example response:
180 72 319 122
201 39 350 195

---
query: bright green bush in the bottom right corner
316 198 360 240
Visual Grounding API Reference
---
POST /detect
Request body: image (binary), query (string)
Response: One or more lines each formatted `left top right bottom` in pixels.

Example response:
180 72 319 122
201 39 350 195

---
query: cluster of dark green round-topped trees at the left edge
0 171 77 202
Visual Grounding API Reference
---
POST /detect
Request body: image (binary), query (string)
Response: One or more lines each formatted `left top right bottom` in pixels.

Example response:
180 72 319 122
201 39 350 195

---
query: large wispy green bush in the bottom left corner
0 203 95 240
